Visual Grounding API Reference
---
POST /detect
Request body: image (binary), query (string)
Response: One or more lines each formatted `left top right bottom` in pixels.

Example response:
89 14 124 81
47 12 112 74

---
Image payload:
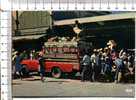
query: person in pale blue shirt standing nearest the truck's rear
81 52 91 82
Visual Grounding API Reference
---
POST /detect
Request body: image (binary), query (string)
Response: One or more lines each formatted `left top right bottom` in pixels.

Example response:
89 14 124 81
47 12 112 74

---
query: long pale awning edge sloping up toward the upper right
54 12 136 25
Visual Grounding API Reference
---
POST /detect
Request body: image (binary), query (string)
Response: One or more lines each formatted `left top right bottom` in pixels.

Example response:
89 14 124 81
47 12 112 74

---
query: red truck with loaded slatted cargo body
21 42 80 78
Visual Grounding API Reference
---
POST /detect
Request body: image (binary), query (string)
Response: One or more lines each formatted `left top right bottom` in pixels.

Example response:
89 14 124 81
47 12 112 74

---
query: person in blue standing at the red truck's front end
15 52 23 80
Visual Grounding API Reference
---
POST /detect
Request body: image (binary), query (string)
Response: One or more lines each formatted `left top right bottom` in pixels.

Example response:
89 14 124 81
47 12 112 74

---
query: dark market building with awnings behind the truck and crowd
12 11 135 50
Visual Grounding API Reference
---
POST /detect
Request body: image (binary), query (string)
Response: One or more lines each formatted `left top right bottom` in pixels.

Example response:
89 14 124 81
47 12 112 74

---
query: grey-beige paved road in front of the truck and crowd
13 77 134 97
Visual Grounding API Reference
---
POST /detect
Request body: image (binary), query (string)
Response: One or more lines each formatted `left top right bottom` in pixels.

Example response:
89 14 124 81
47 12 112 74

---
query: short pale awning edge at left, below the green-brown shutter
12 34 45 41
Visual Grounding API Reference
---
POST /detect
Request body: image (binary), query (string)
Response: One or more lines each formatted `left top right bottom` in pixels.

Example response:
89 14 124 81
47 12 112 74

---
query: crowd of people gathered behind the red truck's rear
81 40 135 83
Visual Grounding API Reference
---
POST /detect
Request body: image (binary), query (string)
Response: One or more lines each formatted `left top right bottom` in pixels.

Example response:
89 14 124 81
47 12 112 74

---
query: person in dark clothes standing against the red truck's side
38 52 45 82
